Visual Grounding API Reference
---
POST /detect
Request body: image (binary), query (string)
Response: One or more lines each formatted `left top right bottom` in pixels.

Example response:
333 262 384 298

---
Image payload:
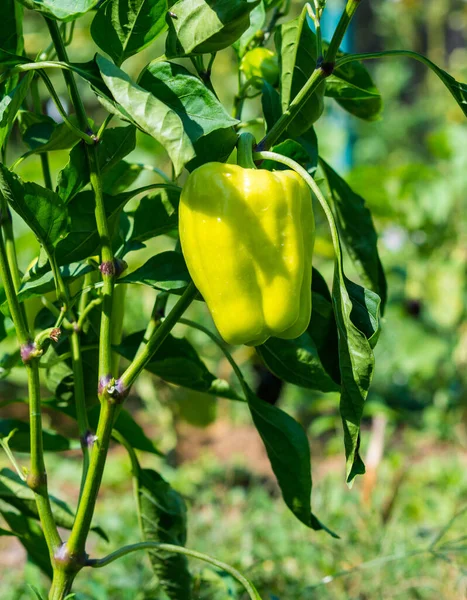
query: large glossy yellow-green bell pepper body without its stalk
179 163 315 346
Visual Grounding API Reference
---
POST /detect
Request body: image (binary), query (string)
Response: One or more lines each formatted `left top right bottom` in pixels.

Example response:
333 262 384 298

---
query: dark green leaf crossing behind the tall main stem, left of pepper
57 125 136 202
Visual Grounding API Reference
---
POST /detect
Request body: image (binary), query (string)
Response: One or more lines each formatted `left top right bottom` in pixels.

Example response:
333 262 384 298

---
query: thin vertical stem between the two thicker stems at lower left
70 327 90 493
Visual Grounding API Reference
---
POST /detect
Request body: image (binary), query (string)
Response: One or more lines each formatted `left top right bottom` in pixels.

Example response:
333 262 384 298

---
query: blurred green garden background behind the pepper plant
0 0 467 600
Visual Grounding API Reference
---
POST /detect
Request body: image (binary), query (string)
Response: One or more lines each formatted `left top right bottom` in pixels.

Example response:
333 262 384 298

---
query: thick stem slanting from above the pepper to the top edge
256 0 361 152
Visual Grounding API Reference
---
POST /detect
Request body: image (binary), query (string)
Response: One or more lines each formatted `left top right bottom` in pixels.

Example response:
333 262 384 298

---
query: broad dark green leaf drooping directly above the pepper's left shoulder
139 60 238 166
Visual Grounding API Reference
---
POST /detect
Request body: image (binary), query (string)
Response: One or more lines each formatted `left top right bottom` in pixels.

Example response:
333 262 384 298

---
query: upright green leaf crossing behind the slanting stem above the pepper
275 8 325 137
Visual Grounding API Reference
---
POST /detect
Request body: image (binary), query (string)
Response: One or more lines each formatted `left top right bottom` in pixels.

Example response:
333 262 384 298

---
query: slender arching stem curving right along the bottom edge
87 542 261 600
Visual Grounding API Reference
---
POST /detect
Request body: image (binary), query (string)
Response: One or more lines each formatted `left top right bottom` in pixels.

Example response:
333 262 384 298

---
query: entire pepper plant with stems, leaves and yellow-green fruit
0 0 467 600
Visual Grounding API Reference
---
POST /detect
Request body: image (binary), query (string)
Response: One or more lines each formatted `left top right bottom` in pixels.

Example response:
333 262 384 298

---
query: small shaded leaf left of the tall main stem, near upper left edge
18 110 79 158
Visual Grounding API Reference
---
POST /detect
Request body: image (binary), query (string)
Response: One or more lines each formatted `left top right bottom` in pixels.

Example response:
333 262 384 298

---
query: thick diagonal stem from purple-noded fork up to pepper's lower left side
120 283 198 389
